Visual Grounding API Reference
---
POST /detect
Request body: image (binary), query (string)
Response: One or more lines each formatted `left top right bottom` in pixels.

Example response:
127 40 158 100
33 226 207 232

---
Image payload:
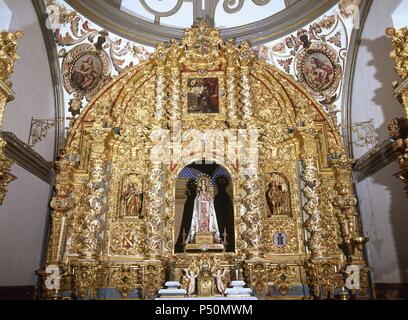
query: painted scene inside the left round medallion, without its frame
71 54 102 91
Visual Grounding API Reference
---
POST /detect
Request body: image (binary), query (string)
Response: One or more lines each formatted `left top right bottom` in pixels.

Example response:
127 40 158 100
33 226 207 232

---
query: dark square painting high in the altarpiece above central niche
187 78 219 114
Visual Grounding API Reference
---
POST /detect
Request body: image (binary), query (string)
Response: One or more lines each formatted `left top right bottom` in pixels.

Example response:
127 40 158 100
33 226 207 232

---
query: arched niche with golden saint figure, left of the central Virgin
120 175 144 219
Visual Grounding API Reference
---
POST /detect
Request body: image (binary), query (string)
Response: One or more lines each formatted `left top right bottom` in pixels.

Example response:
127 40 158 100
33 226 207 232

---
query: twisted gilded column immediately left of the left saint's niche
80 119 110 259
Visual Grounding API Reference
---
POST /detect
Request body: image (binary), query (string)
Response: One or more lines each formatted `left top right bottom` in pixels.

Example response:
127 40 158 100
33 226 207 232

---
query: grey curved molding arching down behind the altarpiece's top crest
66 0 339 46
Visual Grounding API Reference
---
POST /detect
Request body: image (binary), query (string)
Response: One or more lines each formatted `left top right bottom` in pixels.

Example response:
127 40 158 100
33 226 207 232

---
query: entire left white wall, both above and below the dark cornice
0 0 55 286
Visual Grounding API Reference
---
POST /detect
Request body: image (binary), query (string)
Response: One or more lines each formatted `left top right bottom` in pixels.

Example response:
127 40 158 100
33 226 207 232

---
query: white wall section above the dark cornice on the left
2 0 55 161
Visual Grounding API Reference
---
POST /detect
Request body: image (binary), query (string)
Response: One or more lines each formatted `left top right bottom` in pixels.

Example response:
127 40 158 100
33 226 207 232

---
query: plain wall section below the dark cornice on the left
0 165 50 287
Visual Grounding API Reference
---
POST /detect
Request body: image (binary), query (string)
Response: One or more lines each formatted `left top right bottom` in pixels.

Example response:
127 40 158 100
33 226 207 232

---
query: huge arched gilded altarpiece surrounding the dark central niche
44 21 369 299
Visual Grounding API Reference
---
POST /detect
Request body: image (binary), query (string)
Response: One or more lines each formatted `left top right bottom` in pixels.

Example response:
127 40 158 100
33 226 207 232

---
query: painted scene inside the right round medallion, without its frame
303 52 335 91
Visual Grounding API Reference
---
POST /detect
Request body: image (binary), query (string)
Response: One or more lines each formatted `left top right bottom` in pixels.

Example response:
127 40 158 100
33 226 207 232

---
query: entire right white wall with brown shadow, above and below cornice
352 0 408 283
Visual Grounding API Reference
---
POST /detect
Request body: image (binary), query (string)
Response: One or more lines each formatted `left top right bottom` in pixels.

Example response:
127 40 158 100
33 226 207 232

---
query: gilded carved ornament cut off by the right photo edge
387 27 408 194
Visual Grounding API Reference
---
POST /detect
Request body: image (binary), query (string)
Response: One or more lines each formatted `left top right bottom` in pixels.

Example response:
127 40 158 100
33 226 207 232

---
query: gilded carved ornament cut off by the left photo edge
0 31 23 205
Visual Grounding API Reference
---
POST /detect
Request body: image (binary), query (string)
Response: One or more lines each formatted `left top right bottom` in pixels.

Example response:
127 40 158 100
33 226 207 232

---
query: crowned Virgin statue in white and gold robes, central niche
187 176 220 243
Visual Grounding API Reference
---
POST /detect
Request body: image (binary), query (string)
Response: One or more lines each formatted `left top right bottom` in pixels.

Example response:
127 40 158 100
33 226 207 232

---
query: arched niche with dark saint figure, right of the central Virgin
265 173 291 217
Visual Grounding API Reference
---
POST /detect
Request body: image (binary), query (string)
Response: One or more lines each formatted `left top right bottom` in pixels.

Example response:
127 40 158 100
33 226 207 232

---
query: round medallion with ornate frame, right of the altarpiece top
296 44 343 96
